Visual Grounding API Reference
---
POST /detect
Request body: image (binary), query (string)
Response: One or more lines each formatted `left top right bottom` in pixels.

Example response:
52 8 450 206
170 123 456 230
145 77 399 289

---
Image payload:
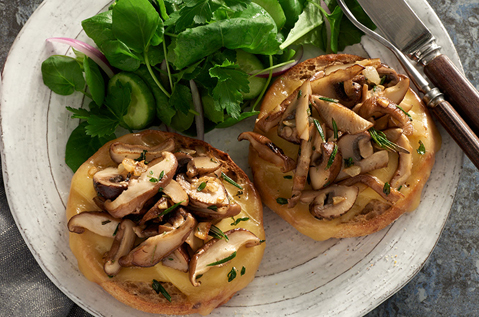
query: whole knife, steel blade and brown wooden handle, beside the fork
358 0 479 135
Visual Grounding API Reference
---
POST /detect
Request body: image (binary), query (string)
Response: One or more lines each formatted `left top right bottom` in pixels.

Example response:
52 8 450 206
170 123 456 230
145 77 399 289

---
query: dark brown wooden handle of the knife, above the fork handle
424 55 479 135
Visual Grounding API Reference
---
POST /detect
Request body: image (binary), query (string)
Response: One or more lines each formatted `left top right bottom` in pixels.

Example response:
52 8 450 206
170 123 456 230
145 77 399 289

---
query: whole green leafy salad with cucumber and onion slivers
42 0 373 171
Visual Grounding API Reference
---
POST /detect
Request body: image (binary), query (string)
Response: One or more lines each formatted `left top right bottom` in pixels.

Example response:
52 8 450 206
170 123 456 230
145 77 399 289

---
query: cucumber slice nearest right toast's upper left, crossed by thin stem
236 50 267 100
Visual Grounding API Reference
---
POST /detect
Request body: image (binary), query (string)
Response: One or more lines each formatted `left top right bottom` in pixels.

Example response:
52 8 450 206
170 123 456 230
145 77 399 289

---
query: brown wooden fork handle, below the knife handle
432 100 479 169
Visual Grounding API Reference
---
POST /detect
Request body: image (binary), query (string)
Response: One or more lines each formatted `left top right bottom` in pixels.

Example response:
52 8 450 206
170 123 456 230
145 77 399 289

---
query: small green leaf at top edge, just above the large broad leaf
175 0 213 33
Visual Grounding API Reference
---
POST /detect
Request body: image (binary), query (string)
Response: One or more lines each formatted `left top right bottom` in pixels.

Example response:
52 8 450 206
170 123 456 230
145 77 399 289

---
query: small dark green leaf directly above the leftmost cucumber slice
100 40 141 72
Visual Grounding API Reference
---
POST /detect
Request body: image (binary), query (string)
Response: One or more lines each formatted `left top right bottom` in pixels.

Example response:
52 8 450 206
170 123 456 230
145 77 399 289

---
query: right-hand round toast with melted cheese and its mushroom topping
246 54 441 240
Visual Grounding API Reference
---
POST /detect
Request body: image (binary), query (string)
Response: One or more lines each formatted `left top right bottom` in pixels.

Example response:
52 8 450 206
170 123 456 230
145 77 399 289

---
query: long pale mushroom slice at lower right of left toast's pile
189 228 261 286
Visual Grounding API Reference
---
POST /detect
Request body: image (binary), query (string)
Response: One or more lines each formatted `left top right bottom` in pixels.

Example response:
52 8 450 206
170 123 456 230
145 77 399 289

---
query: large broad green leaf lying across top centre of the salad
174 3 279 69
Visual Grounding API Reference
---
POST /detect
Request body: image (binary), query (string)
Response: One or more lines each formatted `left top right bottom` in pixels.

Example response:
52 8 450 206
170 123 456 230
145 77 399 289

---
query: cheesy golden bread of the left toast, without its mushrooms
67 130 265 315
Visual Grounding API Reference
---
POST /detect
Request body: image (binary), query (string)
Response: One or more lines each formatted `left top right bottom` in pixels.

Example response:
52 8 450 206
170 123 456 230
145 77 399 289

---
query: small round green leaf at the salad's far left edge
42 55 85 96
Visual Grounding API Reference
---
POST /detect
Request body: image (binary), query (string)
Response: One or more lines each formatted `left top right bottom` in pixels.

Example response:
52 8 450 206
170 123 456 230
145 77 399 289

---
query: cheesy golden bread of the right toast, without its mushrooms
249 54 440 240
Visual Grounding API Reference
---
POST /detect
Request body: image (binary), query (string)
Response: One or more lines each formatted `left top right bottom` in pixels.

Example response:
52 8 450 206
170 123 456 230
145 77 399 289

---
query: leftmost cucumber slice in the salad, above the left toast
108 72 155 130
